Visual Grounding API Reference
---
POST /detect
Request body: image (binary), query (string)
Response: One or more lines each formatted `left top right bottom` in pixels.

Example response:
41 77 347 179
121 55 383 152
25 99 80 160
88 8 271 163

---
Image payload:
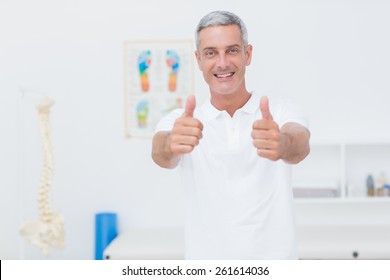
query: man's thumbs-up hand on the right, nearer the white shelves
252 96 285 161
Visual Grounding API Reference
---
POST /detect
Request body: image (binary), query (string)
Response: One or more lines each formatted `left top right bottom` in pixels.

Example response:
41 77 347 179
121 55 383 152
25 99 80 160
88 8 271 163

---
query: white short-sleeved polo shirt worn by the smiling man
156 93 307 259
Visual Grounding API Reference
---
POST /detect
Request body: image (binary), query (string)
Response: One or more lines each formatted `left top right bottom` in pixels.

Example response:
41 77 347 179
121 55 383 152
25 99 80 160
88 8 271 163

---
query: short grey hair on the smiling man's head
195 11 248 49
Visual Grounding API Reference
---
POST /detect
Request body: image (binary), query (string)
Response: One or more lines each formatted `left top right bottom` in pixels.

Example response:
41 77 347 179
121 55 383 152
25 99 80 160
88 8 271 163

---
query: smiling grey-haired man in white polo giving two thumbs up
152 11 310 259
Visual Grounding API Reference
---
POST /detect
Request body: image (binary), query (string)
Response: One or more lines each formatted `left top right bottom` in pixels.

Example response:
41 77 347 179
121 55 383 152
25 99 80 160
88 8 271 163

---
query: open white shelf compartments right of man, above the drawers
293 141 390 199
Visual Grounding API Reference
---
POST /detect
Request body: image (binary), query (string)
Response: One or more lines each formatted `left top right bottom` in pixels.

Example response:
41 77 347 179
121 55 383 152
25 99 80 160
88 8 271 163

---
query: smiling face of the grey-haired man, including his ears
195 25 252 95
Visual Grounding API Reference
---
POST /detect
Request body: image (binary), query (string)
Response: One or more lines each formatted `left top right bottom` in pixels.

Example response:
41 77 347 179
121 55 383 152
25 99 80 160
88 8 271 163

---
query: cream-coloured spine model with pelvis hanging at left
20 97 65 255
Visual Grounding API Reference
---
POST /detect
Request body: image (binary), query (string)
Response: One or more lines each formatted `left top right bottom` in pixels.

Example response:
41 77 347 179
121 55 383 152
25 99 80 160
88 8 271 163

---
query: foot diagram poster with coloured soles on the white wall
125 40 194 138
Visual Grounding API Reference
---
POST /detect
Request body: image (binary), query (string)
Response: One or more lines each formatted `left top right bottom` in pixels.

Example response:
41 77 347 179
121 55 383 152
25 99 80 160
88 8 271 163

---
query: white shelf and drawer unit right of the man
293 141 390 259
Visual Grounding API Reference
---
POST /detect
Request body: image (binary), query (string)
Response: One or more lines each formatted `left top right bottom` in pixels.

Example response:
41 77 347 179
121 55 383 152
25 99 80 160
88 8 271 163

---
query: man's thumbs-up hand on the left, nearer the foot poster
170 95 203 156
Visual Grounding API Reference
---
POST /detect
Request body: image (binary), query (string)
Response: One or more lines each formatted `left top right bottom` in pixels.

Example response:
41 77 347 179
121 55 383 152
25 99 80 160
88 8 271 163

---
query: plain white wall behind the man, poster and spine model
0 0 390 259
